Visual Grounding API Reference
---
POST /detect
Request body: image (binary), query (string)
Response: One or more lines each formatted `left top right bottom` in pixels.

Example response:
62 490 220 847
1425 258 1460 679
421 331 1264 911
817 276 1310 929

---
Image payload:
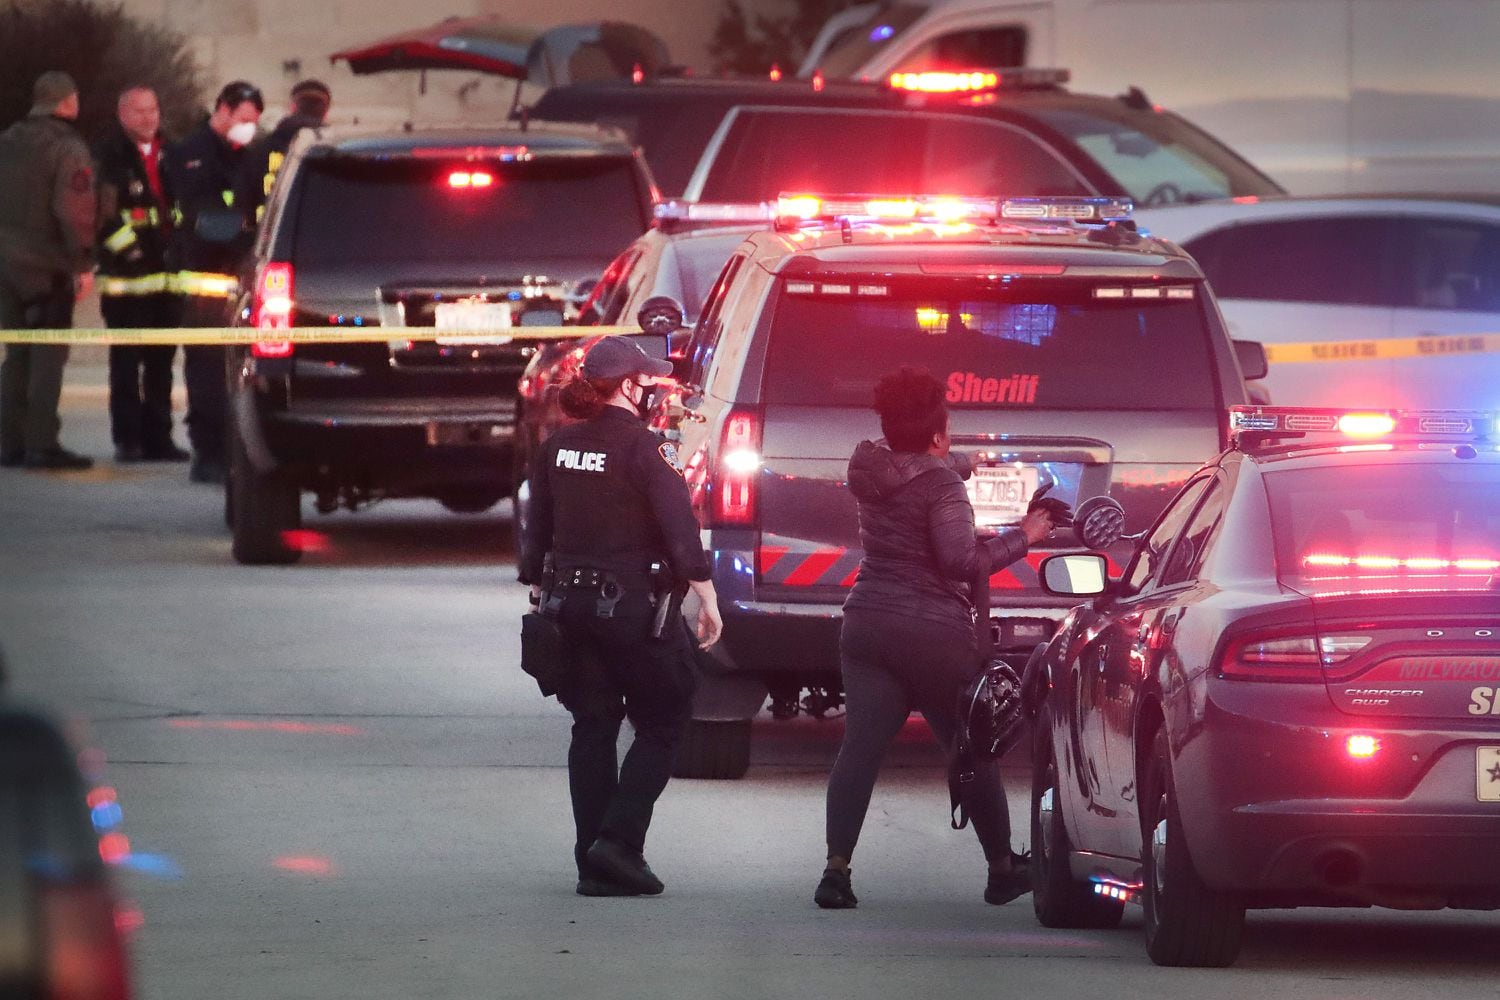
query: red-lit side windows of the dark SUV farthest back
699 108 1092 201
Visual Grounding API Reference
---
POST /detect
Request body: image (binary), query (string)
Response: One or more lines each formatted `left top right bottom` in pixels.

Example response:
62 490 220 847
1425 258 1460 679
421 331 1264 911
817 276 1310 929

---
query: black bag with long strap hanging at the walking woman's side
948 559 1026 831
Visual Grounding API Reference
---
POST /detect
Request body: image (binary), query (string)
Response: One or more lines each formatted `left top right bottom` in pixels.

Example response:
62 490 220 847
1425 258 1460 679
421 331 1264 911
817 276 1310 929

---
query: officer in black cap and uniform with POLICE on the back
521 337 723 895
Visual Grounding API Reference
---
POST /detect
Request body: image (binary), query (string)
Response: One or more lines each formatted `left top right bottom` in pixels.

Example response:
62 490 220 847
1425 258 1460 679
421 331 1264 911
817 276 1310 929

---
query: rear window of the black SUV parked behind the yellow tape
293 157 647 267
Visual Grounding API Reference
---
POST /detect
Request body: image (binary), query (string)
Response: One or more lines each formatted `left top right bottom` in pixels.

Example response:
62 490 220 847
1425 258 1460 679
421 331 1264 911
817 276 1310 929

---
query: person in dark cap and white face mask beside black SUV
165 79 266 483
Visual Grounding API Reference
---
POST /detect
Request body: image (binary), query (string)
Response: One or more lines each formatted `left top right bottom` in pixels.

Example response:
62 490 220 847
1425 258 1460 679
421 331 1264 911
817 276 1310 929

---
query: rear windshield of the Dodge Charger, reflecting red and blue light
1266 459 1500 594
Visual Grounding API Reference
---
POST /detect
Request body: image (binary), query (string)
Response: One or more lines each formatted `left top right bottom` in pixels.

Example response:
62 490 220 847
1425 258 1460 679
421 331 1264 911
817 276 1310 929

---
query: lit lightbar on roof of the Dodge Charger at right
1229 406 1500 445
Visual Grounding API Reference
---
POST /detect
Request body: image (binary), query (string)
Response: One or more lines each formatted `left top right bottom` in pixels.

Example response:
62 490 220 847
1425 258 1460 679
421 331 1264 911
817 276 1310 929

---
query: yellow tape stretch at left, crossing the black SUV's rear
0 327 641 346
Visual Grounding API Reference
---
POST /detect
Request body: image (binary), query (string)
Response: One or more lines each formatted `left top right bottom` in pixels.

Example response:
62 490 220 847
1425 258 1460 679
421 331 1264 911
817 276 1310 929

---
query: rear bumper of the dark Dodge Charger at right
1173 681 1500 909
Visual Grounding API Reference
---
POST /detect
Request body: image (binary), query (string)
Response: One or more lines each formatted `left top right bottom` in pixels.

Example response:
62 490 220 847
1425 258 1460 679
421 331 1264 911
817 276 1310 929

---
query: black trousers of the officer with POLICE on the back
558 591 693 876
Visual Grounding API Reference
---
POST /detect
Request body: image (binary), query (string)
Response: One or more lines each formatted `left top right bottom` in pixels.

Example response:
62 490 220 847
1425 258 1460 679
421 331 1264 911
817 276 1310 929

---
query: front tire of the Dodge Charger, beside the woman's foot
1031 706 1125 928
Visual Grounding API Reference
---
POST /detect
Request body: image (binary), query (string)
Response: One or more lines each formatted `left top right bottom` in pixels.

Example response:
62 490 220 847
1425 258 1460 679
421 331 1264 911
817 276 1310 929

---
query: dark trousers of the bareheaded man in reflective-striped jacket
99 294 180 457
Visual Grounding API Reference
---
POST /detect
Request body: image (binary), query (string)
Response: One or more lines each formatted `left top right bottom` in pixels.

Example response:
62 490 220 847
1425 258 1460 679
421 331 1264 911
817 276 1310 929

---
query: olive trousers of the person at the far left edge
0 274 74 459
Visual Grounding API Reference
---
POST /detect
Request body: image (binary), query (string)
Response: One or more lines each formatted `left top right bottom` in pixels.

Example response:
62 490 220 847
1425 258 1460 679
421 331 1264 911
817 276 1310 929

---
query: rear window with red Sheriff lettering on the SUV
762 276 1218 409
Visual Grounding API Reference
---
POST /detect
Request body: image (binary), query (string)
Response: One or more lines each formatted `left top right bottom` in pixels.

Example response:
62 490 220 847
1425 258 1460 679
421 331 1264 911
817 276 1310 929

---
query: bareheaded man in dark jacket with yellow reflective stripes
95 87 188 462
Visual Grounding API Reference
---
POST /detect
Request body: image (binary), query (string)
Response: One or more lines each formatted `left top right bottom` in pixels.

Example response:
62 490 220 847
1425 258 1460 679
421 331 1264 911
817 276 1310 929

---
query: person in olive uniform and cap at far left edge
0 70 96 469
